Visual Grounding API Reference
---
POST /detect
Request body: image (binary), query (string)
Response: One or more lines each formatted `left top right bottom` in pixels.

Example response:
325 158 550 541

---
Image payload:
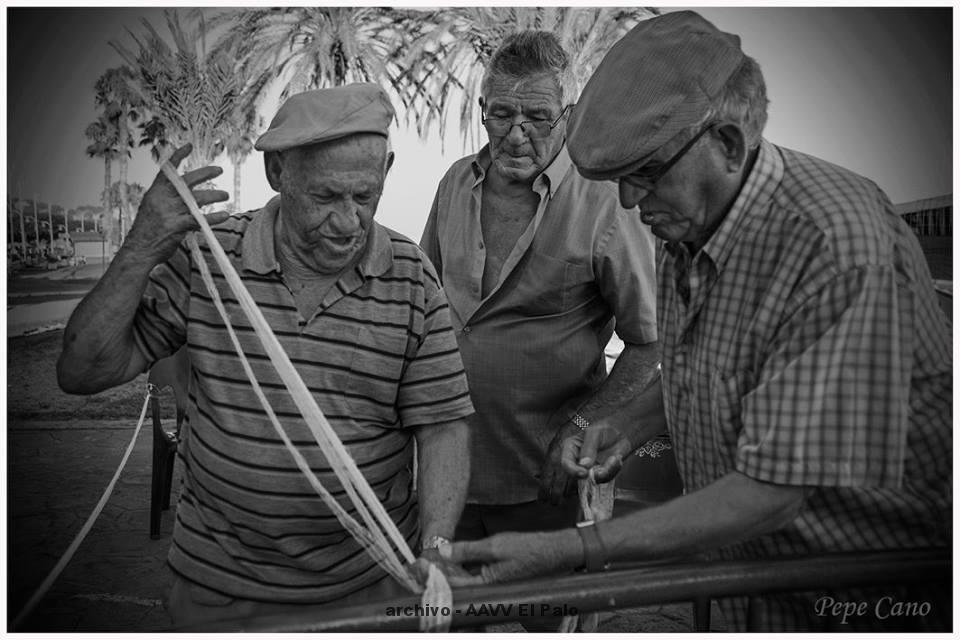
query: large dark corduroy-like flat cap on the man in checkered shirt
567 11 744 180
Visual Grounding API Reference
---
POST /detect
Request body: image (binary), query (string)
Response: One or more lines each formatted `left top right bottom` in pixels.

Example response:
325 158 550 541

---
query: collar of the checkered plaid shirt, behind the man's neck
703 140 783 269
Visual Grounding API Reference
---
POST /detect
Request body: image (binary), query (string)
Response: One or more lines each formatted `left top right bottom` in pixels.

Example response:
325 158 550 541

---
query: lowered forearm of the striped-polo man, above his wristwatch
417 420 470 540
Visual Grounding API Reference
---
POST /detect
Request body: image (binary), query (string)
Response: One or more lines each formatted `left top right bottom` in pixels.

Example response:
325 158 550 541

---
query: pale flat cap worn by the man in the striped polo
254 83 394 151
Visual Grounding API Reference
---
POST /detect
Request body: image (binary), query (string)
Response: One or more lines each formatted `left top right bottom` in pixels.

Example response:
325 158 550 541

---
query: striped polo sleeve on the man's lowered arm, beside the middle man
397 265 473 427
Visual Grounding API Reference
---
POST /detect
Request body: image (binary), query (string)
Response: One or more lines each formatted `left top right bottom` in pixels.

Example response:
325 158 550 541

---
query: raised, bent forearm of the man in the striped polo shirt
57 246 159 394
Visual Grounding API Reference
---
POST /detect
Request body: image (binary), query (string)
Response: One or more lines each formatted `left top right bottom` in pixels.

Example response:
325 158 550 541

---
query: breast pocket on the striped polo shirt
344 326 407 427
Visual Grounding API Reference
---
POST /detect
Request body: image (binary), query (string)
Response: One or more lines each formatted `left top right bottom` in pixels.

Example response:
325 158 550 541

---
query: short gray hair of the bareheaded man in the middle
480 29 579 104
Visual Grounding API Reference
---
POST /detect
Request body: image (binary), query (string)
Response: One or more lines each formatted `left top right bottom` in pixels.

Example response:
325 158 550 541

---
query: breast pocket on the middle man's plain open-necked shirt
516 251 593 316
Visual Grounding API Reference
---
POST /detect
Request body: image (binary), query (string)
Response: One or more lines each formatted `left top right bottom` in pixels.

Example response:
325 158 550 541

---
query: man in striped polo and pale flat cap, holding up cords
59 84 473 625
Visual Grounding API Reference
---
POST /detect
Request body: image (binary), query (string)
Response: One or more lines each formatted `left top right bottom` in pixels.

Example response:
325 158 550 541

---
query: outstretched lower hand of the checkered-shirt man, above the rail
440 529 579 587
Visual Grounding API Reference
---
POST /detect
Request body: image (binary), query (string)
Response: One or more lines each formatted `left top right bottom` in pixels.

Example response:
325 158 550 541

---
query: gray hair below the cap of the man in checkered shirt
689 56 770 149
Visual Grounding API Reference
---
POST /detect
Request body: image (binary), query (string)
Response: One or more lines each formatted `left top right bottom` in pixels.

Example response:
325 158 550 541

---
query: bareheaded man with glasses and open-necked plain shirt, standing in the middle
421 31 659 628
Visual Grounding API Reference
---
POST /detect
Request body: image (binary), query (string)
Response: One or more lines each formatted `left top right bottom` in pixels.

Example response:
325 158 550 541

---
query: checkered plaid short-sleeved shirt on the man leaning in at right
658 141 952 630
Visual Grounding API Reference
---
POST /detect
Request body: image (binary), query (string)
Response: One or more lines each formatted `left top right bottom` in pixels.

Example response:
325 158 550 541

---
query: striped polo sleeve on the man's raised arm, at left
133 244 190 363
